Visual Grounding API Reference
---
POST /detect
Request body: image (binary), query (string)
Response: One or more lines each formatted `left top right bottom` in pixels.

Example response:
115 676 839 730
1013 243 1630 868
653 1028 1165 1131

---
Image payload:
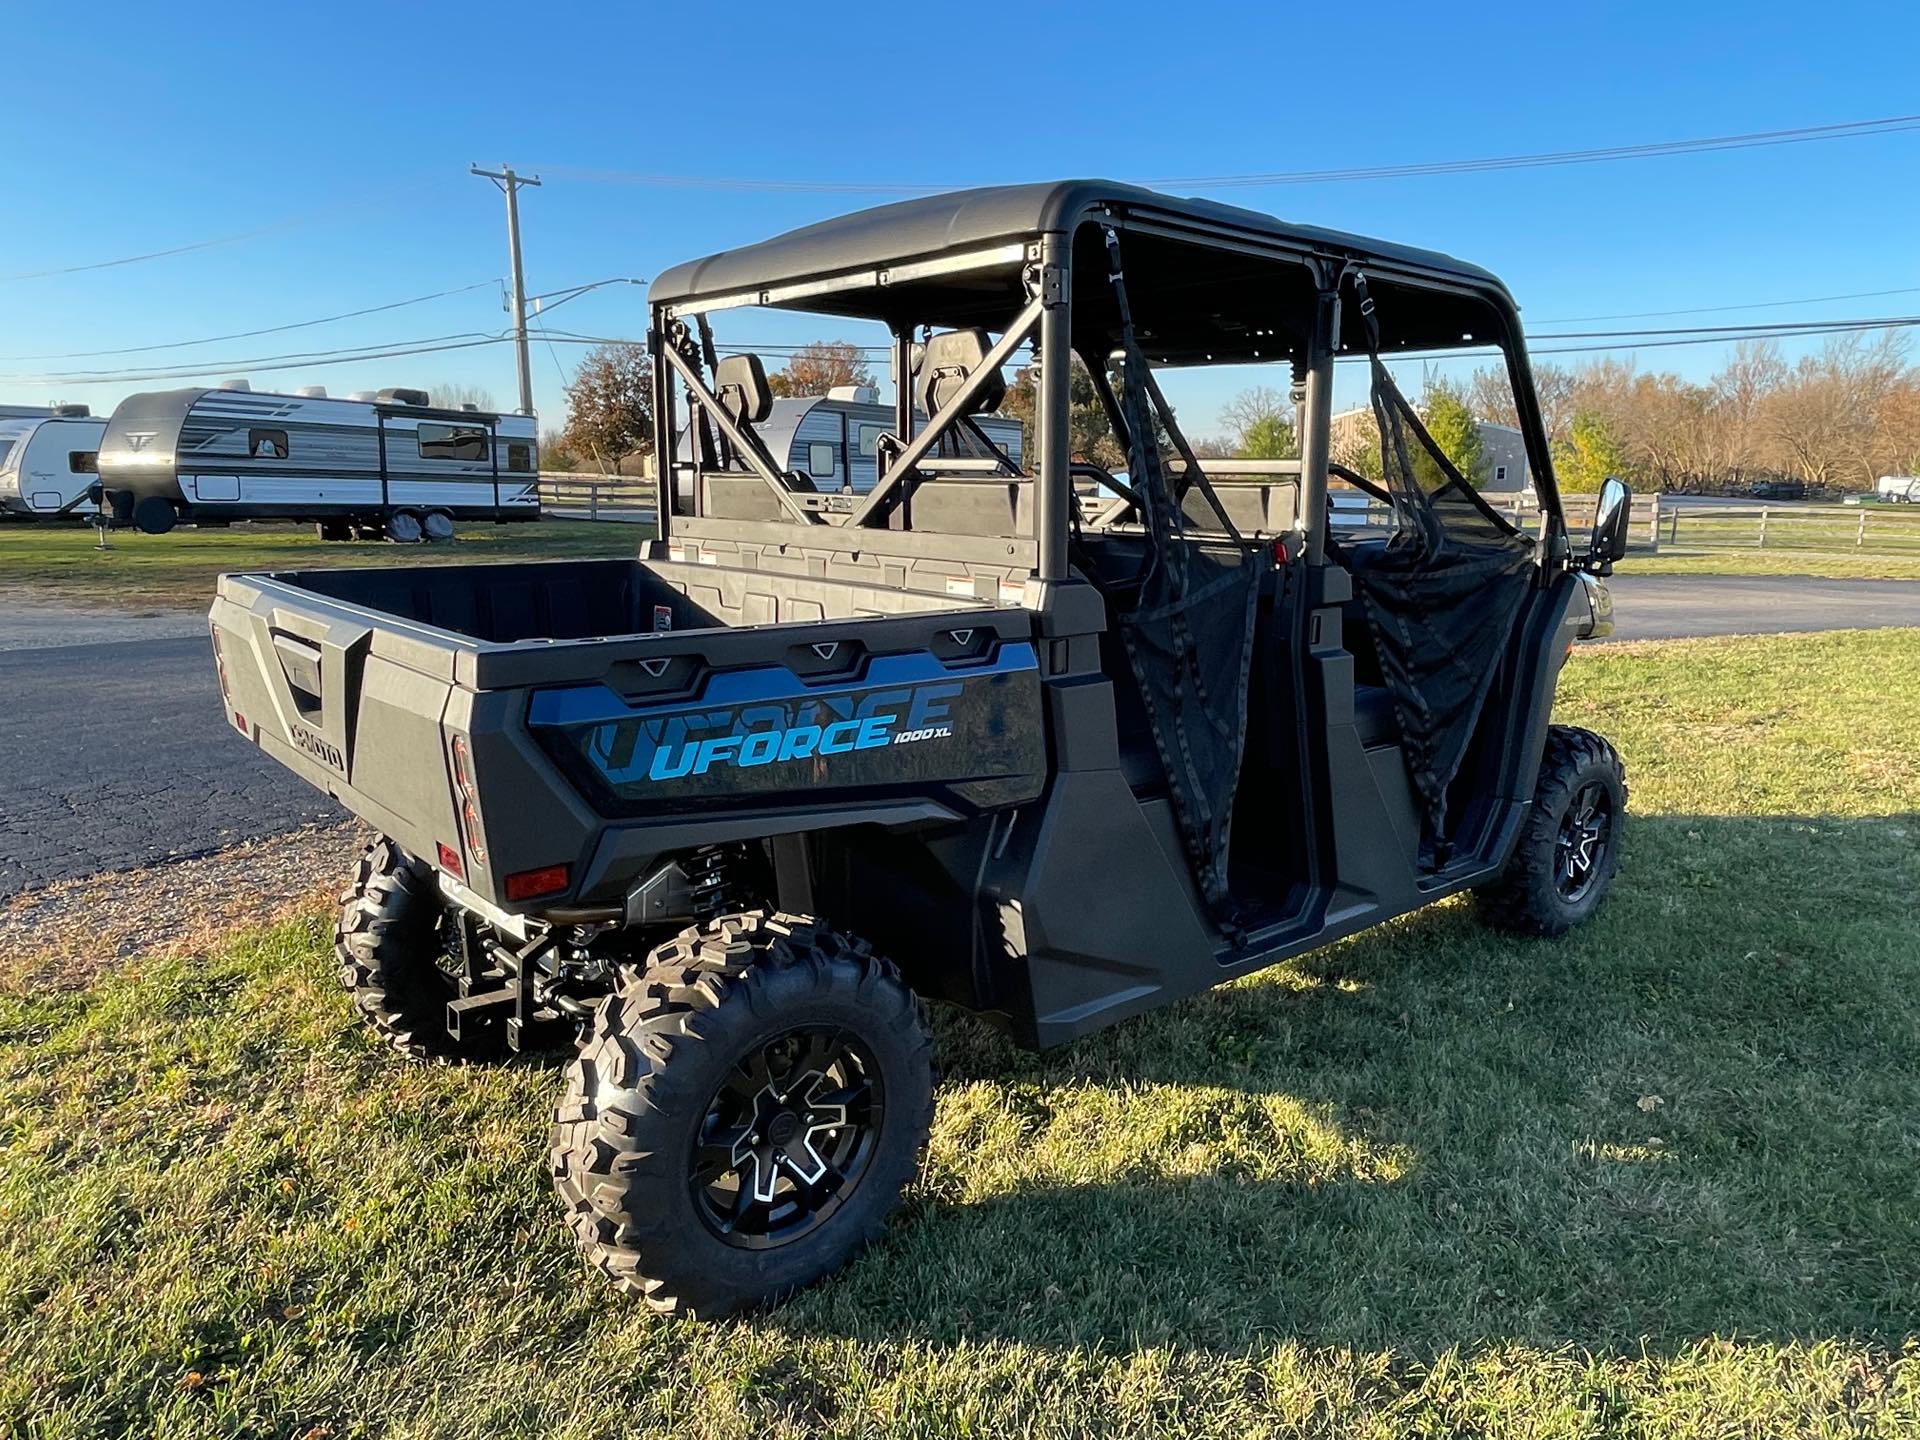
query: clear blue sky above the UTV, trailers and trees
0 0 1920 434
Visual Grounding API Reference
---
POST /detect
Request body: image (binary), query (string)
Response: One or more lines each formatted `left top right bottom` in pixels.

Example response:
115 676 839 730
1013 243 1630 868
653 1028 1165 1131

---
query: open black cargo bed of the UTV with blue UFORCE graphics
211 555 1044 910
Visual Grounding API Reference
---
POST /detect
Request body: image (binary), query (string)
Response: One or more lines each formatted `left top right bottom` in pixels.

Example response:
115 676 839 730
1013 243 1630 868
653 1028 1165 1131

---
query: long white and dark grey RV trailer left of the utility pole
100 388 540 541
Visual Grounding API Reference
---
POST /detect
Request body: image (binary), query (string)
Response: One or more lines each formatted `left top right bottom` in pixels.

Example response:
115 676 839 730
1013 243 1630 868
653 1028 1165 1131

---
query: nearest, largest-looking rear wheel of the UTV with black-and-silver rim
553 912 933 1319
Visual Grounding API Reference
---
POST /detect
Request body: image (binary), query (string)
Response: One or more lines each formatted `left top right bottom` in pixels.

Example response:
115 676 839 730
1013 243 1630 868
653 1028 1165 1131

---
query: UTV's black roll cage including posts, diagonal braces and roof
649 180 1567 582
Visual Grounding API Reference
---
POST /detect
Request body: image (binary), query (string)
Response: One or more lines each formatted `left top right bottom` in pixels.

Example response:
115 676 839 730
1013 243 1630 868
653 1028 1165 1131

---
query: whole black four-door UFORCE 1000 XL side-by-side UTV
211 180 1626 1315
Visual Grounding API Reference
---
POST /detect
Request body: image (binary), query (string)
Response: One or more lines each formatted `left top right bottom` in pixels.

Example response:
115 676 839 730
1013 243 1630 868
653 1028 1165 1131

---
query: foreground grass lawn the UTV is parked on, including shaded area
0 630 1920 1440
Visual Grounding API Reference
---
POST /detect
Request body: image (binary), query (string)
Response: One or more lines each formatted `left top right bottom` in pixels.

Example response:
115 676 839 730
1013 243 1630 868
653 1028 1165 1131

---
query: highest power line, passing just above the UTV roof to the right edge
543 115 1920 196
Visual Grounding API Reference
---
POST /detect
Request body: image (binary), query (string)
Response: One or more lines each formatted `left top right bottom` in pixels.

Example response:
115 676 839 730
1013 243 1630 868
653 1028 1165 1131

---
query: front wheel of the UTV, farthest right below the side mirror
1475 726 1626 935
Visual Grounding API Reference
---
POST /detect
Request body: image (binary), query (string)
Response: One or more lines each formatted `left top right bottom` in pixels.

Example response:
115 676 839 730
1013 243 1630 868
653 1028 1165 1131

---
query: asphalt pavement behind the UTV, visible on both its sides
0 574 1920 897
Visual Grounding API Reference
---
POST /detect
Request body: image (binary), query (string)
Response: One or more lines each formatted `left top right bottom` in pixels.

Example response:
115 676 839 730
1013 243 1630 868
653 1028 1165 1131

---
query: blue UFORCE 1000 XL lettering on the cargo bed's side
606 682 964 785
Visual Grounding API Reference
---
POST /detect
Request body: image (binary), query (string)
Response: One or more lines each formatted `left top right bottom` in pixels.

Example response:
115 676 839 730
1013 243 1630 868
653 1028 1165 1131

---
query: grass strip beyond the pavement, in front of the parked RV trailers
0 520 651 611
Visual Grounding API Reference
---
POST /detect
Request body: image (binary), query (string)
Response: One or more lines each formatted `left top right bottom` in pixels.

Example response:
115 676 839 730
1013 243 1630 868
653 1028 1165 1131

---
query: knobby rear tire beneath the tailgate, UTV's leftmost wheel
334 839 507 1066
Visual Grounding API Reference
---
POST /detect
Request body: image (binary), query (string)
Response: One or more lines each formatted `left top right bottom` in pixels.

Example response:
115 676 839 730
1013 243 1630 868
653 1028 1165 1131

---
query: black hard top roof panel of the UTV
651 180 1511 315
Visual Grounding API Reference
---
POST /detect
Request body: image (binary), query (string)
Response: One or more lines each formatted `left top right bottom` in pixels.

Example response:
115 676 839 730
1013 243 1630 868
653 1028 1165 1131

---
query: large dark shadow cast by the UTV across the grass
776 816 1920 1356
